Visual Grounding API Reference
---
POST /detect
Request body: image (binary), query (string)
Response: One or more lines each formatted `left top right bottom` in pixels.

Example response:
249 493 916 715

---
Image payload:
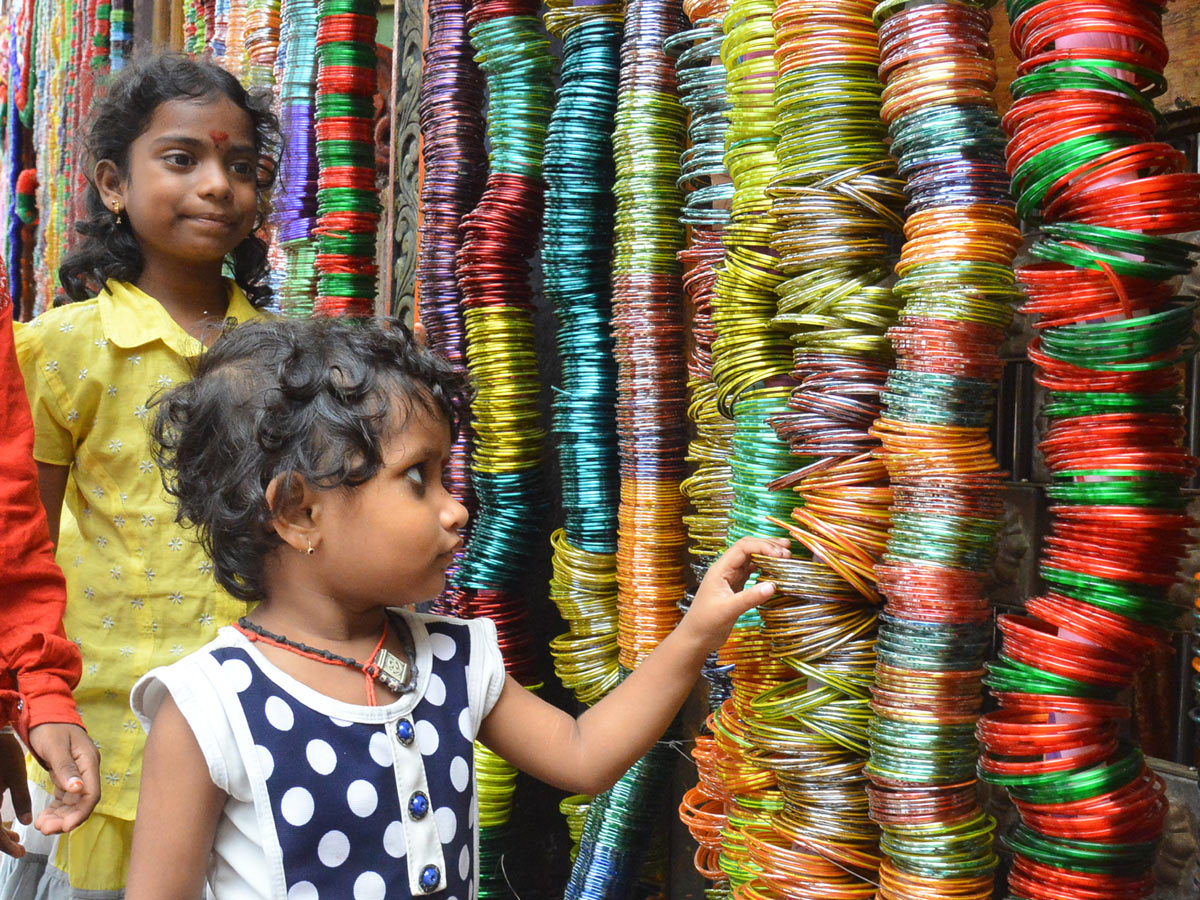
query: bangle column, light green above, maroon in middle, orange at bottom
612 0 688 670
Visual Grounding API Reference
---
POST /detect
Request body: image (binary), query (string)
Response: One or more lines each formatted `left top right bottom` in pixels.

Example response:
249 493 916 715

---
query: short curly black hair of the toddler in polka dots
151 319 467 601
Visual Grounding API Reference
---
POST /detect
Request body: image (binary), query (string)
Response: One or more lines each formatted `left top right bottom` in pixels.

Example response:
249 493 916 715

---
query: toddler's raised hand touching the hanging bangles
680 538 792 650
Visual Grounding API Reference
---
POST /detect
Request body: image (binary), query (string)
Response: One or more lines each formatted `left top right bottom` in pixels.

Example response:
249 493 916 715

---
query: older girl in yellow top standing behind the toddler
0 55 278 900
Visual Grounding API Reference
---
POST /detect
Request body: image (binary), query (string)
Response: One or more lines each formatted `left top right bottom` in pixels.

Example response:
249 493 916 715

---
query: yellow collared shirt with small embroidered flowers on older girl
16 281 260 818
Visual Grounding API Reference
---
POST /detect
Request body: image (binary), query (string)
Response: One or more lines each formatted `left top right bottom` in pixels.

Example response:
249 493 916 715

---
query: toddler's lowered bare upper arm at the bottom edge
125 694 226 900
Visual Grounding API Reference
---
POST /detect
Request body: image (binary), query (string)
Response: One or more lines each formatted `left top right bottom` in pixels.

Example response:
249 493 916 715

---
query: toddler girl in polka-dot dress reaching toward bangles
128 320 788 900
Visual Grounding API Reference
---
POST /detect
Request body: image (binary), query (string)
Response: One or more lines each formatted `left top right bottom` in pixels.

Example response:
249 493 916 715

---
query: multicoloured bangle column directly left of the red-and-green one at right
868 0 1021 900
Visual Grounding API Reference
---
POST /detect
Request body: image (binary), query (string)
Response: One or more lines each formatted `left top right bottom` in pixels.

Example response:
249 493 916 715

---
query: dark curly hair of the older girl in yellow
59 53 282 307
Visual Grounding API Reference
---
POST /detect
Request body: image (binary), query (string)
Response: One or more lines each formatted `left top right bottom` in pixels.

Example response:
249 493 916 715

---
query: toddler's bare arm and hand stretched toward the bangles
479 538 791 794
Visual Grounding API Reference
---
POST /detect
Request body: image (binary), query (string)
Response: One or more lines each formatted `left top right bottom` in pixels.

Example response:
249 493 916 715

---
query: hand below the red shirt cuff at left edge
29 724 100 834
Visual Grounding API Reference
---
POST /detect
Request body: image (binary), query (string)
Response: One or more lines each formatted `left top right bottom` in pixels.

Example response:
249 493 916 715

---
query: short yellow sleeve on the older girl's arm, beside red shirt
13 323 82 466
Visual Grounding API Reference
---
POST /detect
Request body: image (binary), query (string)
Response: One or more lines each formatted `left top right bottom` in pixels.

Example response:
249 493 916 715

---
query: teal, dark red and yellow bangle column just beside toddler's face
454 0 554 898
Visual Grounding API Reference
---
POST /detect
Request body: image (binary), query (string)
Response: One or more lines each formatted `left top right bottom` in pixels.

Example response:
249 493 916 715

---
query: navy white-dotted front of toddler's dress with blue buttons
211 622 475 900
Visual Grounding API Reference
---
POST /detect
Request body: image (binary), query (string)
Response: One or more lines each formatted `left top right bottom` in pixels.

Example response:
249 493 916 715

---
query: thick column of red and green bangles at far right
979 0 1200 900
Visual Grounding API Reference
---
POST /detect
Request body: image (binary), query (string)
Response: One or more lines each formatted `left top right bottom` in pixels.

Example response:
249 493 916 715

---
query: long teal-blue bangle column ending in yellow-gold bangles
542 2 622 706
